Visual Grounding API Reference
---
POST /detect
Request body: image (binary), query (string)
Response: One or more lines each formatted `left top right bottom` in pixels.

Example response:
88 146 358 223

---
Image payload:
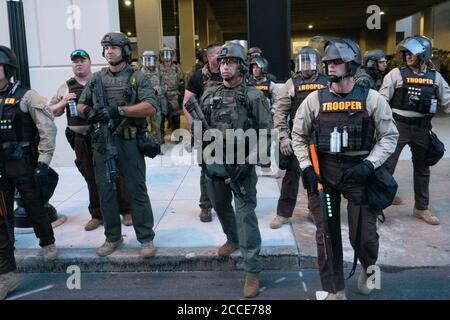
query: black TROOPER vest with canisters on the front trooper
313 85 375 152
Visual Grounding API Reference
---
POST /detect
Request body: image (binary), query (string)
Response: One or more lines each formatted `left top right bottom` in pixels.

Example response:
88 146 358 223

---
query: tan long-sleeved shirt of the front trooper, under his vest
292 85 399 169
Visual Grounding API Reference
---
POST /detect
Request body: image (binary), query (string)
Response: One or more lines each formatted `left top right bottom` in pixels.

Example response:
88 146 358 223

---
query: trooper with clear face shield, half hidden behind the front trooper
270 46 328 229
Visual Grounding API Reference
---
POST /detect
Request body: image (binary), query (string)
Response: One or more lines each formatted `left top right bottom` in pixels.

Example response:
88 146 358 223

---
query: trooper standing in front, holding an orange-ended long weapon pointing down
292 39 398 299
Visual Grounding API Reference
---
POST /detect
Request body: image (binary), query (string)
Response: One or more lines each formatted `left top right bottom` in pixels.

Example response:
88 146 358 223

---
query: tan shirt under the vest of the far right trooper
379 67 450 117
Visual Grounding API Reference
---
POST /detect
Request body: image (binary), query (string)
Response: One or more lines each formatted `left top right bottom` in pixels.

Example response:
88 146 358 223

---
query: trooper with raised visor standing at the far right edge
380 36 450 225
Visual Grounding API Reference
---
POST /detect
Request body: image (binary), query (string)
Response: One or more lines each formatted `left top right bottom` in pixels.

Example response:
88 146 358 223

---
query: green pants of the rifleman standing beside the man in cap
93 136 155 243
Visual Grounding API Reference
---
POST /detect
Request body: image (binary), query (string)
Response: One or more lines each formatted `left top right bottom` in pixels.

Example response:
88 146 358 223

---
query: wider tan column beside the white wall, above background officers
134 0 163 56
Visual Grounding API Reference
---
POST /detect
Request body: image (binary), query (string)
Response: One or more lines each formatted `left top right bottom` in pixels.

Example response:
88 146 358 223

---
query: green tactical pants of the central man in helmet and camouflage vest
206 168 262 274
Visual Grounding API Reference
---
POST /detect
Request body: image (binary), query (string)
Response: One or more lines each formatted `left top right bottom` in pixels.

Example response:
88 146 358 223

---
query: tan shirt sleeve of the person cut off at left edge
20 90 57 165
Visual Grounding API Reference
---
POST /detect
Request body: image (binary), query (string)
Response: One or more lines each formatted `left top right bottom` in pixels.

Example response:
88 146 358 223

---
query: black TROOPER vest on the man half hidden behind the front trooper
289 73 328 131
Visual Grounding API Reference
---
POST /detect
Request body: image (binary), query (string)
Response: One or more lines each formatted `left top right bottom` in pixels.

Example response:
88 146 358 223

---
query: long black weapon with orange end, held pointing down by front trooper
309 141 336 293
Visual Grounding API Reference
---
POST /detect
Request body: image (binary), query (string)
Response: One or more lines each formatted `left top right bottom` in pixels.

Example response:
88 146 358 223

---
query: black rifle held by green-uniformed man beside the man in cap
94 74 118 189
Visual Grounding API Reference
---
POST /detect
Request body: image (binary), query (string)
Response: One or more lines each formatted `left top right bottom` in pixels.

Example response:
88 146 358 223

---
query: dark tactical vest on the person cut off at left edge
0 85 37 143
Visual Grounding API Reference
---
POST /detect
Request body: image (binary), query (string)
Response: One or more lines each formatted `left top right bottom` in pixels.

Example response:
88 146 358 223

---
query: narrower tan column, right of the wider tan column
178 0 196 72
